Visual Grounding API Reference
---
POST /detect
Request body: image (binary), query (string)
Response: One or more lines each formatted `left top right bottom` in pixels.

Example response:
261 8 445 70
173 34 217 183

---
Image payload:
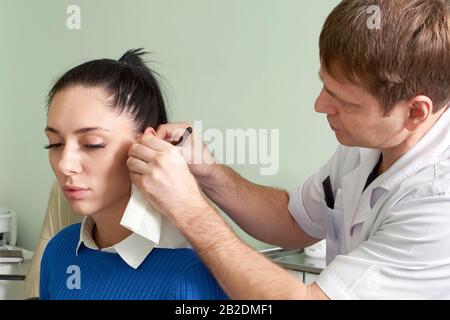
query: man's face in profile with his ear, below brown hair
315 67 408 150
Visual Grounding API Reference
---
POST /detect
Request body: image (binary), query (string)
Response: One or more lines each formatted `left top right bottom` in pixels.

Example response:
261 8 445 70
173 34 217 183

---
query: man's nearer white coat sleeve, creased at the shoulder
316 195 450 300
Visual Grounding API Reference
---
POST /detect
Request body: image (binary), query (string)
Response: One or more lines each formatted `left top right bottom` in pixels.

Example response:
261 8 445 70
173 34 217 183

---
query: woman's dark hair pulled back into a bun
48 48 167 133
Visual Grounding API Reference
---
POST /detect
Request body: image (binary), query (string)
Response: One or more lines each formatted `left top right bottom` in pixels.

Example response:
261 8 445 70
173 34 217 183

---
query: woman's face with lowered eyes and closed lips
46 86 135 215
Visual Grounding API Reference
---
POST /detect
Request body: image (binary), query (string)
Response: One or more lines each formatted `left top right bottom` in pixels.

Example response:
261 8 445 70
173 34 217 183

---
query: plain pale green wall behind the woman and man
0 0 339 249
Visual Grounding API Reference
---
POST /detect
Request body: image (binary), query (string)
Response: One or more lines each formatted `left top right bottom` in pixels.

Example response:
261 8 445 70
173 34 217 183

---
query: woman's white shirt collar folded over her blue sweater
76 217 155 269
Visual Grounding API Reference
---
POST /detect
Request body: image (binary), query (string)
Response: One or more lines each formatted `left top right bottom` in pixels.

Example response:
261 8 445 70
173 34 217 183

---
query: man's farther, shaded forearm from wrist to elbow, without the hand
197 164 318 248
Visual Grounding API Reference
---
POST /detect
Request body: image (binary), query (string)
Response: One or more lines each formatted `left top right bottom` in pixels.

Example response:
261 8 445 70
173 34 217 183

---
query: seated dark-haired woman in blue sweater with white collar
40 50 226 299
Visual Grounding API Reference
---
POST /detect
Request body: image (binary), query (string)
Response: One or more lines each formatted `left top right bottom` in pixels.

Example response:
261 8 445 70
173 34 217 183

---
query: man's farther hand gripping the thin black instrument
156 123 216 179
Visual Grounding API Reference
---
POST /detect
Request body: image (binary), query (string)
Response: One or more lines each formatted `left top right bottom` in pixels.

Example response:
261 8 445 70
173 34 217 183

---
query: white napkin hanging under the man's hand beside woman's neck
120 184 192 249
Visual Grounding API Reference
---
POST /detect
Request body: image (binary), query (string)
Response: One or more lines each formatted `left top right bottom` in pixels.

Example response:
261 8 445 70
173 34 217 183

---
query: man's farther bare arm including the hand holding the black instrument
156 123 319 248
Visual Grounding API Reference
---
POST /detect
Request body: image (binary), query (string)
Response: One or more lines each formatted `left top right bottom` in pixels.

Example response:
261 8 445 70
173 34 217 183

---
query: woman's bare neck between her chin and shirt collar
91 194 132 249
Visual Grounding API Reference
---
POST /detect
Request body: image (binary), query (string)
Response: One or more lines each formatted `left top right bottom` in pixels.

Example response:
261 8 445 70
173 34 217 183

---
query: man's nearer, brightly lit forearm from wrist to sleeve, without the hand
176 200 328 300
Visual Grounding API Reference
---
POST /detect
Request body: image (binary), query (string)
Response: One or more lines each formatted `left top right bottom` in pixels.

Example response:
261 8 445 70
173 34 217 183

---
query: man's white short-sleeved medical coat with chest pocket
289 111 450 299
